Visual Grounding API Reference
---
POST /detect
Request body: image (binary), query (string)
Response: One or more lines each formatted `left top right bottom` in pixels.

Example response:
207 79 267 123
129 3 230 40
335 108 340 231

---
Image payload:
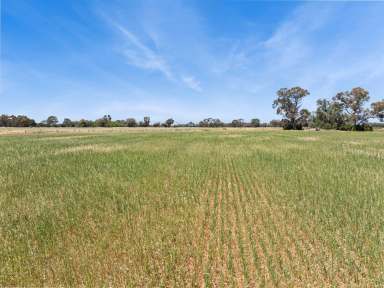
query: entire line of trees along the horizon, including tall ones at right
0 87 384 131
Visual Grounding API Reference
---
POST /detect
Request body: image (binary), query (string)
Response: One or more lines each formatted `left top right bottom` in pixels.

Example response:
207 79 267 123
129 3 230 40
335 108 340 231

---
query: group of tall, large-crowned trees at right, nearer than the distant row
272 87 384 131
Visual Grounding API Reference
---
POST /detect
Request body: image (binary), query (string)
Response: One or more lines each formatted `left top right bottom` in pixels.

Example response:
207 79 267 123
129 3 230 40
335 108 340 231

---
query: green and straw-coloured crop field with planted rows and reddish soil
0 129 384 287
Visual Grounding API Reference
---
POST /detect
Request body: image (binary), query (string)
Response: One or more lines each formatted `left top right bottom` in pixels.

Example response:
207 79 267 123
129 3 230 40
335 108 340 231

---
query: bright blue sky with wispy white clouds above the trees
0 0 384 123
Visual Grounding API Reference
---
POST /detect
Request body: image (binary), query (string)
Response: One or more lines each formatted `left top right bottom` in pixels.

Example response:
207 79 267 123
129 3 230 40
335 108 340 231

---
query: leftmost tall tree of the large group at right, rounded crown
272 87 309 130
